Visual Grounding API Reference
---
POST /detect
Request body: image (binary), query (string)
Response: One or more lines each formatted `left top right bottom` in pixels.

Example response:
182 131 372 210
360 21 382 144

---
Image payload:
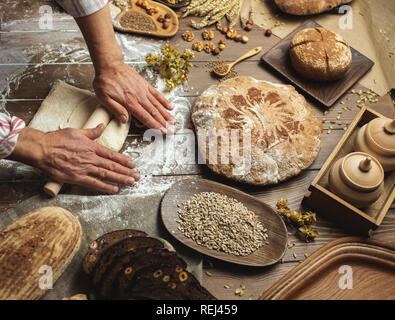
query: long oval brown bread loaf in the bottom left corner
0 207 82 300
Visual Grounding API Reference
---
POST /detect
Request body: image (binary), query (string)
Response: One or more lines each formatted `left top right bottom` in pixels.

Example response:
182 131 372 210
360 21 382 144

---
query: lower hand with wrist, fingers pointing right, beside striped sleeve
9 125 140 193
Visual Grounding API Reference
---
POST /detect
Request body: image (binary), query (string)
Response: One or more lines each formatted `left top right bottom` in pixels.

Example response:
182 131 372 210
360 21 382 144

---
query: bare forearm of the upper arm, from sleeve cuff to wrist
76 5 123 74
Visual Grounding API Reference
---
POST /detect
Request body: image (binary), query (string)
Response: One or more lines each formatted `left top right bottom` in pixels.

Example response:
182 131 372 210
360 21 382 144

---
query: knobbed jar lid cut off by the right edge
366 118 395 156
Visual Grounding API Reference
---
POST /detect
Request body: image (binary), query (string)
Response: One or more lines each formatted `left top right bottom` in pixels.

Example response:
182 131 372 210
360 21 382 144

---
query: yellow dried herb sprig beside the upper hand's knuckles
145 43 195 91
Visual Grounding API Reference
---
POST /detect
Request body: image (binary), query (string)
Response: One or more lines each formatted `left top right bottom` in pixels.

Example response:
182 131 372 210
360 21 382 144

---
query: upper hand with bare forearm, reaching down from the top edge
76 5 175 133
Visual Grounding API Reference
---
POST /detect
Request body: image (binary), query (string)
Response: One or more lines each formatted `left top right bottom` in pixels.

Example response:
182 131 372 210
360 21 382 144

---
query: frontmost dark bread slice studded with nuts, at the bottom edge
129 266 216 300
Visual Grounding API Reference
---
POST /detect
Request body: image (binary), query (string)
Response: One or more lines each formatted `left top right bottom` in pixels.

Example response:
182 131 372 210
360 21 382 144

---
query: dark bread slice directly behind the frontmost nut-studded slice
114 250 187 298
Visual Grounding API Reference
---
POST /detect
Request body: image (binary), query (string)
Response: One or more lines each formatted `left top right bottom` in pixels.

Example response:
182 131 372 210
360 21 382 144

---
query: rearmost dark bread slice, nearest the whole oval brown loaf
83 229 147 274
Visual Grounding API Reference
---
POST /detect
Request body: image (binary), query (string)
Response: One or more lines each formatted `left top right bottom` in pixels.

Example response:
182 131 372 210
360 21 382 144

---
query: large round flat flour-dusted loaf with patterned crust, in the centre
192 77 322 185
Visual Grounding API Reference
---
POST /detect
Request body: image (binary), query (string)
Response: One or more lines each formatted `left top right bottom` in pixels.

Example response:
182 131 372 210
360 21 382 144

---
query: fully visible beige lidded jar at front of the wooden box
328 152 384 208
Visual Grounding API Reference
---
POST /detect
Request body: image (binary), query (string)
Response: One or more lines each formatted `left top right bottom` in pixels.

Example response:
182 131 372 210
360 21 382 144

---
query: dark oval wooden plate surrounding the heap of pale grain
161 179 287 267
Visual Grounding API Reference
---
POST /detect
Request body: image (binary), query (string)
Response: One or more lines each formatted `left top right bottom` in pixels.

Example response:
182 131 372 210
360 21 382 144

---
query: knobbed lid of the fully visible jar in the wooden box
340 152 384 192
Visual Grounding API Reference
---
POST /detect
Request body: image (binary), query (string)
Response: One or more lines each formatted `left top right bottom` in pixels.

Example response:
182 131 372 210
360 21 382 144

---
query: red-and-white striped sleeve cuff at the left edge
0 113 25 159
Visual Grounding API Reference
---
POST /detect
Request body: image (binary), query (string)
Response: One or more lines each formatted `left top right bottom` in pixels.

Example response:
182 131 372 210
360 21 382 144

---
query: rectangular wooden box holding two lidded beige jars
303 107 395 235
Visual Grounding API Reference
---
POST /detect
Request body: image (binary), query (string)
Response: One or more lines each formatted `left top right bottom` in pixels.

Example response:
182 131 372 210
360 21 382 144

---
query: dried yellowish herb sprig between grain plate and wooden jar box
276 199 318 242
